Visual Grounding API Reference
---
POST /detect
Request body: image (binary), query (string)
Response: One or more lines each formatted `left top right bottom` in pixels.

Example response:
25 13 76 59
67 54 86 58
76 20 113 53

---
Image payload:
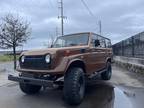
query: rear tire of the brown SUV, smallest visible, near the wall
101 62 112 80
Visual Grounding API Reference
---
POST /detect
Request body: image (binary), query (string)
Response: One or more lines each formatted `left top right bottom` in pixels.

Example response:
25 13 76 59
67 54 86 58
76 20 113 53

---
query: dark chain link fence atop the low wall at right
113 32 144 58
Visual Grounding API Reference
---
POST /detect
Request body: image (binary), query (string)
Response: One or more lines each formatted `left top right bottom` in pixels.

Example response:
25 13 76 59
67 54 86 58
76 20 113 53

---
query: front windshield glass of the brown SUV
53 34 89 48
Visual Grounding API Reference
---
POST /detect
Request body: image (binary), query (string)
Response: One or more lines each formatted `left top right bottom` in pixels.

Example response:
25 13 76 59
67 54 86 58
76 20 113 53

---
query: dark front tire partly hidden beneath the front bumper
19 83 41 95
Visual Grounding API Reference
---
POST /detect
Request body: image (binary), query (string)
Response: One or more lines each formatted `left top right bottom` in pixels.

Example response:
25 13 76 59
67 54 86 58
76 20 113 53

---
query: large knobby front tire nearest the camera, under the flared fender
63 67 85 105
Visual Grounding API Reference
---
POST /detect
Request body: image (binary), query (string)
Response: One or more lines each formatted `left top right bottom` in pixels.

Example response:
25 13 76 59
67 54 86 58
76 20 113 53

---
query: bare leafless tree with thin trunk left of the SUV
0 14 31 69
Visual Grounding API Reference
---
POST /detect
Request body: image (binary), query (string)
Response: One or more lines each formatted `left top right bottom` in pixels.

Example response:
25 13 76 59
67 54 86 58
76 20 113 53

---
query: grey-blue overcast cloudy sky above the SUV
0 0 144 49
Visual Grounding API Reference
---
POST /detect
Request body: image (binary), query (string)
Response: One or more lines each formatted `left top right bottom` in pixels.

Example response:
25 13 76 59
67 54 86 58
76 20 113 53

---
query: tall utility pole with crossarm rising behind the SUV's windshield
58 0 66 36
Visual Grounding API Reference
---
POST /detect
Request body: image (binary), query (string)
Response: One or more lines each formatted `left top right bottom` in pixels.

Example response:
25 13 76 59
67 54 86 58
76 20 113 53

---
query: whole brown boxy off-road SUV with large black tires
8 32 112 104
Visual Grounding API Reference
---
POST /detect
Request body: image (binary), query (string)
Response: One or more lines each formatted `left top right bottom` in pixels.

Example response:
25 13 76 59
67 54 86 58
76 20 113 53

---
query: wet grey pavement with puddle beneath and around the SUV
0 63 144 108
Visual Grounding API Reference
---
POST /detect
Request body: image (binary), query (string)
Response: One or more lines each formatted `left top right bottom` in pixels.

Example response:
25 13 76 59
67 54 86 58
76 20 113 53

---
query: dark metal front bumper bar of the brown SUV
8 75 54 87
